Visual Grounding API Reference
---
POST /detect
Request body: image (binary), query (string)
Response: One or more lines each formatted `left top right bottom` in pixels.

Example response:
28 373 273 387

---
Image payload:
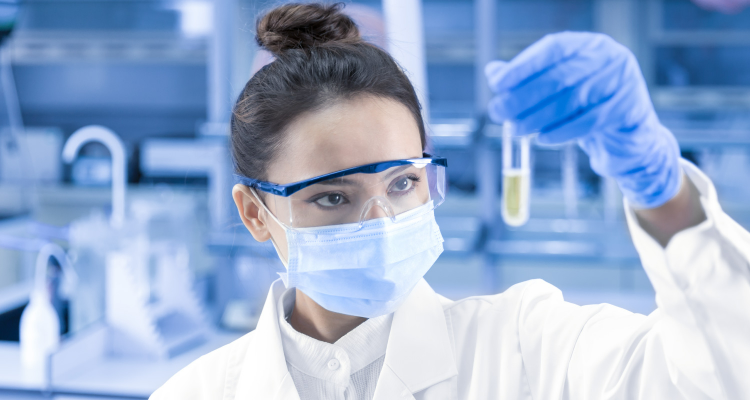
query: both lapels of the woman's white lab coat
232 279 458 400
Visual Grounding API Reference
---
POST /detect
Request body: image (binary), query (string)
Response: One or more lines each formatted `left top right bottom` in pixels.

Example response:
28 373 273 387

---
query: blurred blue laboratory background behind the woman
0 0 750 400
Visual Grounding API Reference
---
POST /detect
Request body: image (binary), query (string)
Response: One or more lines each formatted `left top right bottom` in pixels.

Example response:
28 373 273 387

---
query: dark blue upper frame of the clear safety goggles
234 153 448 197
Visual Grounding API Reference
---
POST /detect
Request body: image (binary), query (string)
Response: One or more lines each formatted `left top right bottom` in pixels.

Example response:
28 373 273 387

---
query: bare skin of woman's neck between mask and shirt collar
289 289 367 343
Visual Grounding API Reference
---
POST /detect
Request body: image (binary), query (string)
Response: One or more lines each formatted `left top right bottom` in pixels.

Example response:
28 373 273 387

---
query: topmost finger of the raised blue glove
485 32 611 93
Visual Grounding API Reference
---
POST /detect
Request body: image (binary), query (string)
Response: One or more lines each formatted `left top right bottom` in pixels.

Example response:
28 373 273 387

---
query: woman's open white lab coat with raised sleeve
151 163 750 400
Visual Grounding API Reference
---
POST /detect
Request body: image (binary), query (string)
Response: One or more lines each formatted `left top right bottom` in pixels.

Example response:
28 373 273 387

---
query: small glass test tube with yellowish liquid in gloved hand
502 121 531 226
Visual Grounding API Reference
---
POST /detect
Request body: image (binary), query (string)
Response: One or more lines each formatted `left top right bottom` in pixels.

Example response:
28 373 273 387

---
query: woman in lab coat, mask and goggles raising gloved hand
152 4 750 400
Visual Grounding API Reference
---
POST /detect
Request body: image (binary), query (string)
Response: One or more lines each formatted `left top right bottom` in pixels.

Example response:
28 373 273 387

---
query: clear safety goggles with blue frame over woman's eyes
235 153 448 231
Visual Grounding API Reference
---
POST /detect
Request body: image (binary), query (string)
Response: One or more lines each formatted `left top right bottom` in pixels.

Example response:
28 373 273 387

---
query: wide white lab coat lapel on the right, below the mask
374 279 458 400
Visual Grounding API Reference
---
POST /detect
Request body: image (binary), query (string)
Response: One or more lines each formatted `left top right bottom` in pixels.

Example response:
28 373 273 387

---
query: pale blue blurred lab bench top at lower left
0 332 240 399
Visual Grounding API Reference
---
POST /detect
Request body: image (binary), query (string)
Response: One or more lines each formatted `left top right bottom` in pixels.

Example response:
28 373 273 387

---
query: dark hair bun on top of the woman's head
256 3 362 55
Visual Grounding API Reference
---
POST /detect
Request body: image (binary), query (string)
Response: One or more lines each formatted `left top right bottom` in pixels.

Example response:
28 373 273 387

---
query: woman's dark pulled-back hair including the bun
231 3 425 180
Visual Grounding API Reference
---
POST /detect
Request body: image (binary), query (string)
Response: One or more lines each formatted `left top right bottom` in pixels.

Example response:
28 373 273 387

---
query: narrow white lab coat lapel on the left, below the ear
234 279 299 400
